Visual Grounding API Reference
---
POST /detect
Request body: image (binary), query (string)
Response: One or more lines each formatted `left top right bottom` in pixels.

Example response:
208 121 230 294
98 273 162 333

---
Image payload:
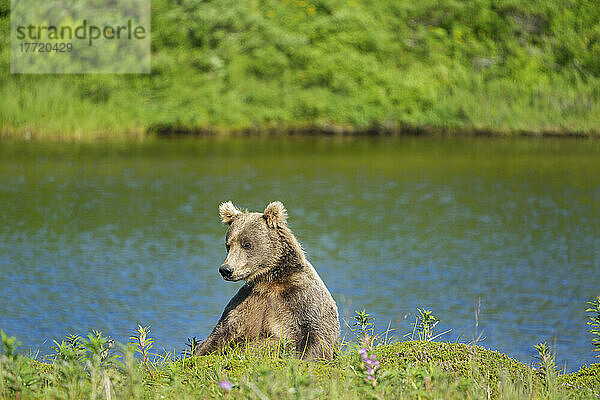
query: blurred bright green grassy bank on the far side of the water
0 0 600 140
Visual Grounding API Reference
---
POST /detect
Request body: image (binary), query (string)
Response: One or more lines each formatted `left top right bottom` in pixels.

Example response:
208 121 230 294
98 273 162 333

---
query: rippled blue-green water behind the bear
0 138 600 370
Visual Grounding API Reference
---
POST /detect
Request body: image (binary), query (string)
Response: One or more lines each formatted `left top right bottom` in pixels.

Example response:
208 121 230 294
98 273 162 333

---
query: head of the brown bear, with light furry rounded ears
219 201 305 282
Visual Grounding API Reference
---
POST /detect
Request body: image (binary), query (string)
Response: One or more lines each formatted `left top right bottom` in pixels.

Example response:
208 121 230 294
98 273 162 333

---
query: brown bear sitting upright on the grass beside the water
196 201 340 359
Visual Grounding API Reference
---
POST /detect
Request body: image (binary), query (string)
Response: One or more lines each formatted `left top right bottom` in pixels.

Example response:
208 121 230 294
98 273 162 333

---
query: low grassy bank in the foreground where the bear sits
0 341 600 399
